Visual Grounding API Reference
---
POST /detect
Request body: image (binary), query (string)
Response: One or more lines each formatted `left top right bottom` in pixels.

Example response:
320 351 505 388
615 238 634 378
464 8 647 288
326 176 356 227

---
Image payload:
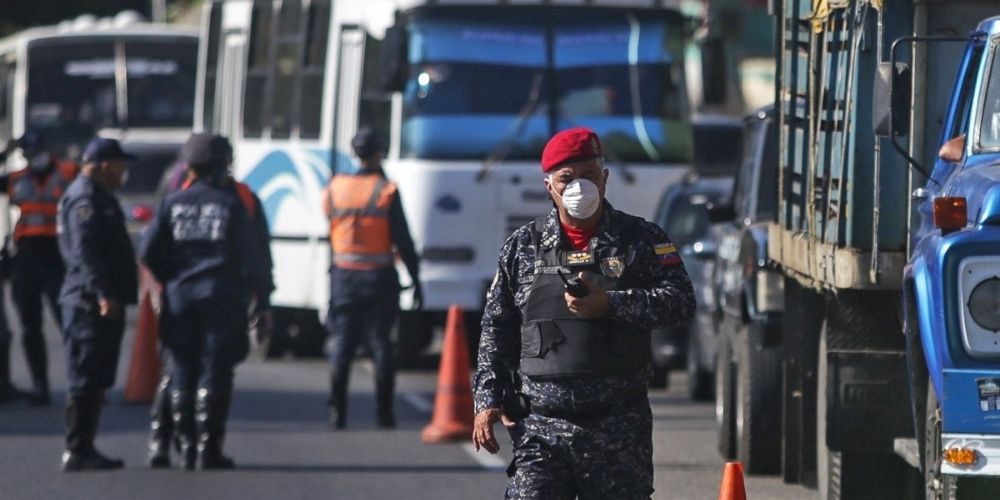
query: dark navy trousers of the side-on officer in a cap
62 304 125 397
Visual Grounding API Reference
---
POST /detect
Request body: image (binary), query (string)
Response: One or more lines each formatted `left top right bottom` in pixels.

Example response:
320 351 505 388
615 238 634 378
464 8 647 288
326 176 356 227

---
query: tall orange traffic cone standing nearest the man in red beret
420 305 472 444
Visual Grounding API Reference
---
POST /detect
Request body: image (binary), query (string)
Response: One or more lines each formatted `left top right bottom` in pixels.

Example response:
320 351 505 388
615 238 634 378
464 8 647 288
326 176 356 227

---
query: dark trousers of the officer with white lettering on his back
161 297 249 394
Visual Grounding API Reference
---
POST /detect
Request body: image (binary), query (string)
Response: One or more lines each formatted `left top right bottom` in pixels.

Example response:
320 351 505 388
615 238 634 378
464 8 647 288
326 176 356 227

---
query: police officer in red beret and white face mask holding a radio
472 128 695 500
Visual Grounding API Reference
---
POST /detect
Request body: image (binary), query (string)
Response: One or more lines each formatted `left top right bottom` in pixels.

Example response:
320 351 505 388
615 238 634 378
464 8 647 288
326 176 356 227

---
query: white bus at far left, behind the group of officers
0 11 198 233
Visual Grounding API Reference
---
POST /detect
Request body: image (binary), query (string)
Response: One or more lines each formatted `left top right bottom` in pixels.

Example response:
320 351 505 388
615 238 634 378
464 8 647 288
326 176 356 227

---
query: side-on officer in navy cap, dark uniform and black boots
58 137 138 472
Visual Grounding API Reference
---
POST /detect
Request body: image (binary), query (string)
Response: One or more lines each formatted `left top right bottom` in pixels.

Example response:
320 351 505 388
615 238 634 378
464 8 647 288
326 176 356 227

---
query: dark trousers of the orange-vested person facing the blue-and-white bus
326 283 399 411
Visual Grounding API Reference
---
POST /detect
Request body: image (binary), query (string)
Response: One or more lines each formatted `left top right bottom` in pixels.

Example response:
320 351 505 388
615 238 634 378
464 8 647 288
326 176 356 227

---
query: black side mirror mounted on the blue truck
872 63 912 137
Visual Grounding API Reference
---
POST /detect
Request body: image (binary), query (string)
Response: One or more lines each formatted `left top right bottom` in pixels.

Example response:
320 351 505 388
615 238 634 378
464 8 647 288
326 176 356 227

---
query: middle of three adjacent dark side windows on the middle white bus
268 2 303 139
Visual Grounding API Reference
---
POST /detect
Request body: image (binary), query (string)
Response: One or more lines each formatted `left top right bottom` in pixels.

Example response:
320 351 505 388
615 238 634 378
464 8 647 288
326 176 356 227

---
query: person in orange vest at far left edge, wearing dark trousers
0 132 79 405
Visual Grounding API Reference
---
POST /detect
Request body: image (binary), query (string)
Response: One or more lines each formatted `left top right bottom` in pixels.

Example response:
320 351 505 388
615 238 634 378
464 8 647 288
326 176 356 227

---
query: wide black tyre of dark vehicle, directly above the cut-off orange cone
736 322 781 474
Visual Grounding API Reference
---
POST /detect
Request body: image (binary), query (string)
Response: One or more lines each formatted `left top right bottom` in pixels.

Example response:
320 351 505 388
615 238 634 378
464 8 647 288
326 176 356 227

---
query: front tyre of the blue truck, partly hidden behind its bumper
924 381 1000 500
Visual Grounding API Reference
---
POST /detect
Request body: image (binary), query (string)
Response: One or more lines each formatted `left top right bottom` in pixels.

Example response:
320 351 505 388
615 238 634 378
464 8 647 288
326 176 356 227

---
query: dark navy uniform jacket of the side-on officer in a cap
58 175 138 306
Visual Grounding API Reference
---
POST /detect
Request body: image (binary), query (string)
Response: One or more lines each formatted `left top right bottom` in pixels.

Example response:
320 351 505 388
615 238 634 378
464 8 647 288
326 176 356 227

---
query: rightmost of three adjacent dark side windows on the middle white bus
299 2 330 139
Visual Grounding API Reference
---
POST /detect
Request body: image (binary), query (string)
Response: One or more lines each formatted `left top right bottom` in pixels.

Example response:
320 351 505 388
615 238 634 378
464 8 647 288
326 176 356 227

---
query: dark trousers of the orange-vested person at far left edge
11 237 66 390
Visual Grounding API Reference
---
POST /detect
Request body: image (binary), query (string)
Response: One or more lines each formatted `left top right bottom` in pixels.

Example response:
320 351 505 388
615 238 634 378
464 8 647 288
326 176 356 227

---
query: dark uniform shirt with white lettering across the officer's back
139 176 271 306
